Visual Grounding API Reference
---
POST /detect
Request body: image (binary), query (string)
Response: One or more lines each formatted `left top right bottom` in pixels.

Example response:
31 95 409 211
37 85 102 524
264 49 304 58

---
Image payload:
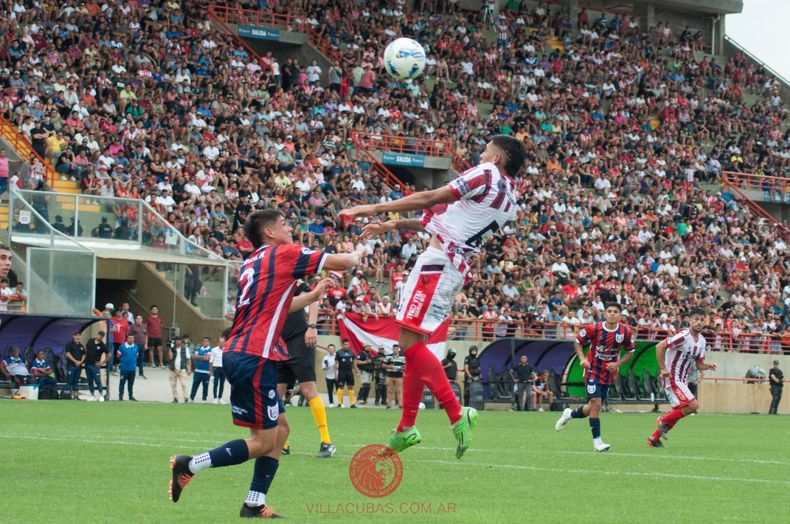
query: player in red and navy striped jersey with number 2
170 210 359 518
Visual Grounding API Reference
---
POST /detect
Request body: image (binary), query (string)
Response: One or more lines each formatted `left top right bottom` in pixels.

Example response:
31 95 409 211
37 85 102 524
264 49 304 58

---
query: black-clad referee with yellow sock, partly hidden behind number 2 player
277 282 335 458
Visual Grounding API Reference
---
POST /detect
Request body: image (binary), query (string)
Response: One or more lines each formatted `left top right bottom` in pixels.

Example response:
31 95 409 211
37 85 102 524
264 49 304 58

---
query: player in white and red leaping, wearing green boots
341 135 526 458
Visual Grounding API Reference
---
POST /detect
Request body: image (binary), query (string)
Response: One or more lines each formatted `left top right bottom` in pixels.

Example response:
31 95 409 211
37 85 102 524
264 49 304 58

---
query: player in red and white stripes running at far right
647 309 717 448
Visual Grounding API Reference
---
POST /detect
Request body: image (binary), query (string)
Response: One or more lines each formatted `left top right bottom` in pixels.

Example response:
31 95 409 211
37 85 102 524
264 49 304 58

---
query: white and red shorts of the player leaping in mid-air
395 247 464 335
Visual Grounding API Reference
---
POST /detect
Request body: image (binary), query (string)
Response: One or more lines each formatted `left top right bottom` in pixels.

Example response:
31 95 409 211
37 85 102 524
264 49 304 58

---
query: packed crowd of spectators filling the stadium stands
0 0 790 342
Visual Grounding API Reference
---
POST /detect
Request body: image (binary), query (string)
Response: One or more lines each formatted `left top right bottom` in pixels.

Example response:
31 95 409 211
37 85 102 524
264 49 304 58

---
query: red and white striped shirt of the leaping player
422 162 518 274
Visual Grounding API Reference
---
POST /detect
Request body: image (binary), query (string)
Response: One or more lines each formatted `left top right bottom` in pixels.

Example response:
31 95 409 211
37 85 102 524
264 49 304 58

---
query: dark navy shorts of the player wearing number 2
222 351 285 429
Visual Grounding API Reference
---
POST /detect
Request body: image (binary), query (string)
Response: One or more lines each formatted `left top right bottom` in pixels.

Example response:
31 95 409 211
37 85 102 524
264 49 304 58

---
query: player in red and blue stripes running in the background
554 303 635 451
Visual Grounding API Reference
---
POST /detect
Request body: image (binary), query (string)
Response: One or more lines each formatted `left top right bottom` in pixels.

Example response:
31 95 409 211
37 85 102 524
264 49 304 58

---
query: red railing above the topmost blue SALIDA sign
208 4 343 64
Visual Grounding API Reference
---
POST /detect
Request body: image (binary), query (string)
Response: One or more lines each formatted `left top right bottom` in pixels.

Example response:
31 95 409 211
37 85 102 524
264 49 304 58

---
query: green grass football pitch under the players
0 401 790 523
